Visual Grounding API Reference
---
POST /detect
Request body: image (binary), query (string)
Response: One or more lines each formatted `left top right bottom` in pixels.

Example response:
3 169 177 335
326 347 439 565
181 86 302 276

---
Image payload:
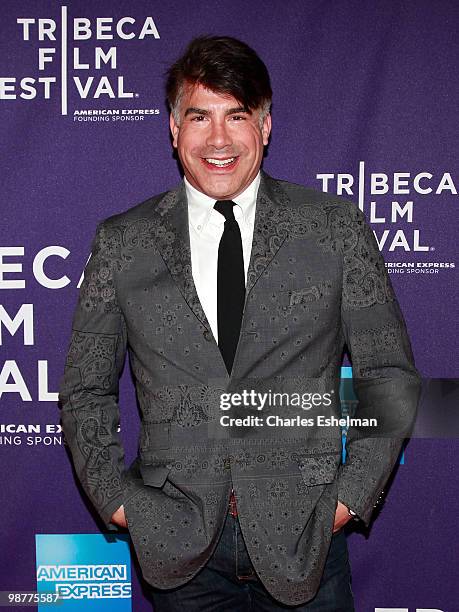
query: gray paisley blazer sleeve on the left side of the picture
59 223 126 531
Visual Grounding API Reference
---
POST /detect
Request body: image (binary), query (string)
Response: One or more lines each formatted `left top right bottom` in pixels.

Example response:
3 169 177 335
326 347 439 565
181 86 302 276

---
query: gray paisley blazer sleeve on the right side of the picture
338 204 421 526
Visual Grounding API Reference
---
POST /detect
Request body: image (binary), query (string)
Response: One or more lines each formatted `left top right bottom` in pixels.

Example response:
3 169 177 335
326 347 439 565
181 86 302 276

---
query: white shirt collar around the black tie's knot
184 171 260 232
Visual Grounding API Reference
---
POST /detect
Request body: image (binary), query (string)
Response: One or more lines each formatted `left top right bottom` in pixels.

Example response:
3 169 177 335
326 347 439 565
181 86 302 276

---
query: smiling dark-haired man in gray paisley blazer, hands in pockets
60 37 419 612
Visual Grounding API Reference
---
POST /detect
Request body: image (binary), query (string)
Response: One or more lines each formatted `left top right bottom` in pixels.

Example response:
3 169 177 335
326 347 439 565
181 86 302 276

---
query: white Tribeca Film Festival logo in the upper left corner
0 6 160 121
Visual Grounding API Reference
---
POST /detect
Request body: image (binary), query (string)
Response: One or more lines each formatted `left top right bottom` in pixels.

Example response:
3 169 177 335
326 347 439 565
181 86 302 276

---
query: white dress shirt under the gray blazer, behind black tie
185 172 260 342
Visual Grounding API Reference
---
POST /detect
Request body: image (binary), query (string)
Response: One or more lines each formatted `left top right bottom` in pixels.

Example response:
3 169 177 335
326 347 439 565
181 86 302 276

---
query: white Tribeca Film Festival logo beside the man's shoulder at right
316 161 457 274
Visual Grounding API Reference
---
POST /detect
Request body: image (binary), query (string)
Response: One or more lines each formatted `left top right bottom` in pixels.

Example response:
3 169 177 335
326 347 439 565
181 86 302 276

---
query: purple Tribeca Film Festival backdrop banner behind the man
0 0 459 612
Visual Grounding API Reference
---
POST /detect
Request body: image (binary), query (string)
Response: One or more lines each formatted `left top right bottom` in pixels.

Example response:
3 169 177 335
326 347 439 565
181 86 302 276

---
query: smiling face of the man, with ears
170 85 271 200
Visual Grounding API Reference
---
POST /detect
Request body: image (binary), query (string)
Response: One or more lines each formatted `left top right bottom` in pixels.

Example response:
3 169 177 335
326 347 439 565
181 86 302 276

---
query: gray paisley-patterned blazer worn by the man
60 172 420 605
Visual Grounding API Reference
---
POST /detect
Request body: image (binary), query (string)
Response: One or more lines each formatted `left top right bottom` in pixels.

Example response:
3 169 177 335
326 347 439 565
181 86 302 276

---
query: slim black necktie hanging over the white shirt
214 200 245 374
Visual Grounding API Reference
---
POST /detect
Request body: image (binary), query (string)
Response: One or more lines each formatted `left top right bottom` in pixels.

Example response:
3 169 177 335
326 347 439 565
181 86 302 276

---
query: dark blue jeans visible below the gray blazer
148 512 354 612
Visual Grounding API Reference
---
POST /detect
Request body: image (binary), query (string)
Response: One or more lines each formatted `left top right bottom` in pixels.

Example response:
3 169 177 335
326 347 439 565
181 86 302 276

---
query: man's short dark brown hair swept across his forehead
166 36 272 119
